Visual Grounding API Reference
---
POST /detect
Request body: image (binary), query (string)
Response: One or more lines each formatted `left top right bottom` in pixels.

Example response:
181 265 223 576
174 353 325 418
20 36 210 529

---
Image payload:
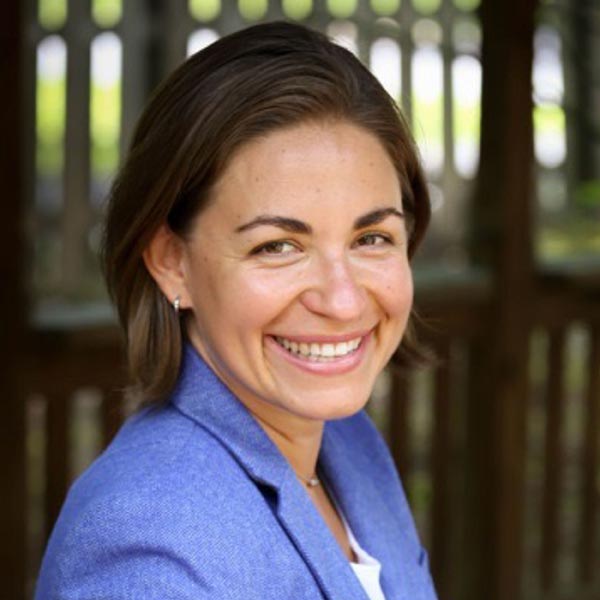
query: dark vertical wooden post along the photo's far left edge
0 2 27 600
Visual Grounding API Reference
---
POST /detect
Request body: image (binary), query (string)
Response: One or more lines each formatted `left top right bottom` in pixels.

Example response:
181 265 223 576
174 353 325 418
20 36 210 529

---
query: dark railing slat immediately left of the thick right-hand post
431 340 455 600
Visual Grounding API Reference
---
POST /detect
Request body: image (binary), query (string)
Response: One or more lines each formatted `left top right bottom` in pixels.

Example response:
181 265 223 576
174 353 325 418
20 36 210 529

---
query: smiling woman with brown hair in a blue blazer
37 23 435 600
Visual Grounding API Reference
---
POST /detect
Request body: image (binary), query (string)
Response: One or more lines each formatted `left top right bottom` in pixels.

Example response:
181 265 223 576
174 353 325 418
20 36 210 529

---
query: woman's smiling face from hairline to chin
182 122 412 421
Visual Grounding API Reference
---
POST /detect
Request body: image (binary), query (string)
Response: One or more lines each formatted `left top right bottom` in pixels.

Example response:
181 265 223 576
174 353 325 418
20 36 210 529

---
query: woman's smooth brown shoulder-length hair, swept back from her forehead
102 22 430 402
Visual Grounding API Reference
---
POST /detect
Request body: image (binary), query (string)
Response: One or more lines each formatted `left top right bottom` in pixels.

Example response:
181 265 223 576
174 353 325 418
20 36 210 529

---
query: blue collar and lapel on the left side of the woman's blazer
171 346 367 600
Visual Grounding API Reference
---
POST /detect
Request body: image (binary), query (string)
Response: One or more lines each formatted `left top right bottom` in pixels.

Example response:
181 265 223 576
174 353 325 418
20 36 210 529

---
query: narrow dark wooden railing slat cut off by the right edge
579 325 600 587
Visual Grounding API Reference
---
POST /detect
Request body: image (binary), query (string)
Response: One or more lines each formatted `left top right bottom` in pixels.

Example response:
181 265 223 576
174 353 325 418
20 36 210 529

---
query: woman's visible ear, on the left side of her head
142 224 190 308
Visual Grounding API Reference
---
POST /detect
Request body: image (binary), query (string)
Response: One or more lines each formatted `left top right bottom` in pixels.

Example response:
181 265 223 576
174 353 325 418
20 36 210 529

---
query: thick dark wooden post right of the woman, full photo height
463 0 536 600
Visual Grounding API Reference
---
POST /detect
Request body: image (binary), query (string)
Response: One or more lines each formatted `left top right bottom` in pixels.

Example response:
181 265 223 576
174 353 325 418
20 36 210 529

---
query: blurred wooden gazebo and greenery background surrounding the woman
0 0 600 600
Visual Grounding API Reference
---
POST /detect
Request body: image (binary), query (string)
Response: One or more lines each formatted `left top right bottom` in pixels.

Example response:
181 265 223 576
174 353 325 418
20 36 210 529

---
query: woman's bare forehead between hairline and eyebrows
207 121 401 220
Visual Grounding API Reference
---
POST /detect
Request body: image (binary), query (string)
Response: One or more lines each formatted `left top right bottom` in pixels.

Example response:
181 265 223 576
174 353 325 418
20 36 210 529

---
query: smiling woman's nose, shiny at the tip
302 256 367 322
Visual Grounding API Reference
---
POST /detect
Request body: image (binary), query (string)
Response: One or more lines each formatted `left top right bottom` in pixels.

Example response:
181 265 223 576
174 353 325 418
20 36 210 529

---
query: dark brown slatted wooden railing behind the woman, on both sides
26 274 600 600
